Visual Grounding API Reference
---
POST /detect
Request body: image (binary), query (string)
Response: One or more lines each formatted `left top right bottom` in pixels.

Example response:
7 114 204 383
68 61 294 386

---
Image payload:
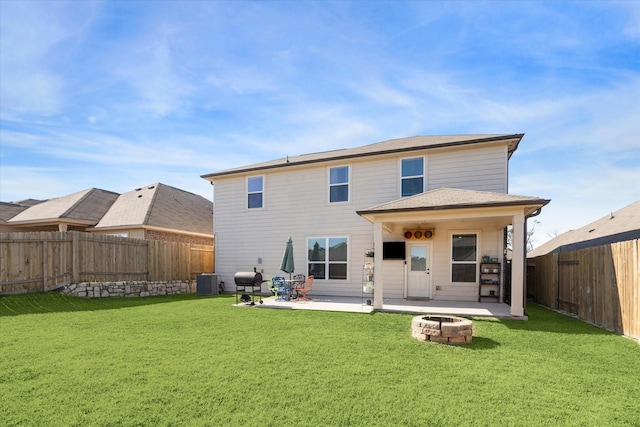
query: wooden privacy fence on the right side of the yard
527 239 640 339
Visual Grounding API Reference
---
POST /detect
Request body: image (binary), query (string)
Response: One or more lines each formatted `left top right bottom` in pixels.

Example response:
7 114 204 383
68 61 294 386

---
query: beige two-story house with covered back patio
203 134 549 316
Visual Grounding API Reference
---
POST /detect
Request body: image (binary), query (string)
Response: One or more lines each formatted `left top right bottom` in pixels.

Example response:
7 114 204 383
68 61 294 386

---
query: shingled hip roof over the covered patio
357 188 549 216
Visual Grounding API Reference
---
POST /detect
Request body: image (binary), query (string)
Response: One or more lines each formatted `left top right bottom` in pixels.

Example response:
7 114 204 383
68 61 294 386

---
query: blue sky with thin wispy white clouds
0 0 640 245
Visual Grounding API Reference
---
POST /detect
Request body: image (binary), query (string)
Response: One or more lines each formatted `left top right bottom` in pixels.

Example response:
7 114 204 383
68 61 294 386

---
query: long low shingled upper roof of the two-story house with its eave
202 134 524 179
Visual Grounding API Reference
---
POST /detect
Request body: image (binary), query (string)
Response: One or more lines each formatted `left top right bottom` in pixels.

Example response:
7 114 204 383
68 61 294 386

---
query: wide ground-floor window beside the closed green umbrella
307 237 349 280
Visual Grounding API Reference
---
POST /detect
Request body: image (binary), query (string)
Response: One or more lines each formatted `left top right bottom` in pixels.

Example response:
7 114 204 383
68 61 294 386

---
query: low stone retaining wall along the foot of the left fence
60 280 196 298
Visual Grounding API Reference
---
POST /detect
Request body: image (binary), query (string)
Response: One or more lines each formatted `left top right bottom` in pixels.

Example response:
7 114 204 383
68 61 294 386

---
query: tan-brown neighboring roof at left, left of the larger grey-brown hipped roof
7 188 118 226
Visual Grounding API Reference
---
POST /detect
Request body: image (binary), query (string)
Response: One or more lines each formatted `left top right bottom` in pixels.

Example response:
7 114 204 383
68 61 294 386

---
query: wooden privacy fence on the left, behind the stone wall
0 231 214 295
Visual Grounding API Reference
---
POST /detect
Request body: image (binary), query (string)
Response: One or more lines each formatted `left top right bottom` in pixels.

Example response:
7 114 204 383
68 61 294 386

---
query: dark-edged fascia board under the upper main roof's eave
200 133 524 181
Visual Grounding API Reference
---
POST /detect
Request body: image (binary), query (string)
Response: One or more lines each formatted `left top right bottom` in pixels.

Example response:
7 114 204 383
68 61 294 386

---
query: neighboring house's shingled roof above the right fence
527 200 640 258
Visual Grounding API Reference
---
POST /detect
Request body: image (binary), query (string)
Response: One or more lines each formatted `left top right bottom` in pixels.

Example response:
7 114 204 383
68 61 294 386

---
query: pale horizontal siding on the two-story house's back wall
214 146 507 298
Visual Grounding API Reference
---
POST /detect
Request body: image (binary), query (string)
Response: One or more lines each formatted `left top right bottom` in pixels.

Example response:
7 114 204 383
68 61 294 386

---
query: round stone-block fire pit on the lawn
411 315 473 344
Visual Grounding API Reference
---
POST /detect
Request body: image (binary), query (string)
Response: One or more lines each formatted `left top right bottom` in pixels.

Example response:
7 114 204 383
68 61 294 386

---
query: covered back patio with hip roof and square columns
356 188 549 318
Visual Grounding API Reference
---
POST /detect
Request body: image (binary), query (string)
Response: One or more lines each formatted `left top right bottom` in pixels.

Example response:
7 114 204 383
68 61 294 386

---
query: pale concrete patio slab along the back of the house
237 296 527 320
